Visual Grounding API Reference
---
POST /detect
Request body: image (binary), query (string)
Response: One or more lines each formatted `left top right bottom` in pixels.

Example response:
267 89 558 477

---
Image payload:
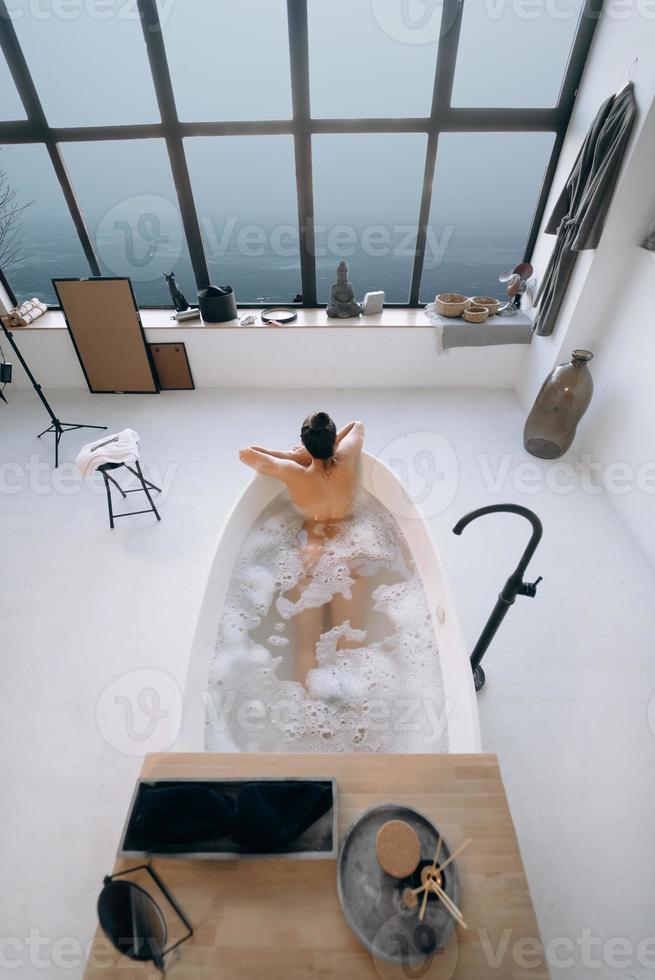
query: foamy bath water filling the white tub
205 490 448 752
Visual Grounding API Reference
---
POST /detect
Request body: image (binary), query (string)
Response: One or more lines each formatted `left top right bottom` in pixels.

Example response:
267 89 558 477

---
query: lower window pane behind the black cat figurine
62 140 196 306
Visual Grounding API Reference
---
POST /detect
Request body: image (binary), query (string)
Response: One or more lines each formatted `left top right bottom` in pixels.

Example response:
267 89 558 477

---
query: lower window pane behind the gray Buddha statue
313 133 427 303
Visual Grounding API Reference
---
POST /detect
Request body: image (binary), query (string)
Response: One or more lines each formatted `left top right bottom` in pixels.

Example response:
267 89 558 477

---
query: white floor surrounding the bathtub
0 390 655 980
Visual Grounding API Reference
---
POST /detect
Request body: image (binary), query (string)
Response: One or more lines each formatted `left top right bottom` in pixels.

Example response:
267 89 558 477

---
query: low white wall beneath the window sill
3 325 527 390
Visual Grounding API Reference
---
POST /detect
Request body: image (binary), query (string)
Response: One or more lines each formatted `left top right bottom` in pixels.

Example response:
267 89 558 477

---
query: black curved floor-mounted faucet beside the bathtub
453 504 543 691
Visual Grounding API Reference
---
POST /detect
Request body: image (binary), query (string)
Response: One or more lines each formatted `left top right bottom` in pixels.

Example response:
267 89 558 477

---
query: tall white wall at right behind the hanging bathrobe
517 0 655 564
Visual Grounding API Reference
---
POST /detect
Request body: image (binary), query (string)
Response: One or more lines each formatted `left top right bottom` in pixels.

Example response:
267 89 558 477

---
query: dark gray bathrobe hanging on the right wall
535 82 637 337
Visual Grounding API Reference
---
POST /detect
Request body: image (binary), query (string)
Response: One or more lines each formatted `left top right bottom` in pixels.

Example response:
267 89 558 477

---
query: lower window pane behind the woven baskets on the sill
421 133 555 303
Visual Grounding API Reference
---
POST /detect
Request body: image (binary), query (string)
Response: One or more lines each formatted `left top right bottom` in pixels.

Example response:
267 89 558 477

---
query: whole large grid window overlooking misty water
0 0 602 307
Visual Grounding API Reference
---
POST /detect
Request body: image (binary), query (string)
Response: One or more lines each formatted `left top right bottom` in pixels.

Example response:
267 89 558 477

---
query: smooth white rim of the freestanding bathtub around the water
175 453 480 752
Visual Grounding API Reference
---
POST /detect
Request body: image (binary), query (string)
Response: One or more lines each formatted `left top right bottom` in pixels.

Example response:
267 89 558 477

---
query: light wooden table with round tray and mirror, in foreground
85 753 549 980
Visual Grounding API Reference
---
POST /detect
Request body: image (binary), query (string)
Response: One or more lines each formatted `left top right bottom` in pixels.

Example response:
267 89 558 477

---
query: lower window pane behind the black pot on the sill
185 136 301 303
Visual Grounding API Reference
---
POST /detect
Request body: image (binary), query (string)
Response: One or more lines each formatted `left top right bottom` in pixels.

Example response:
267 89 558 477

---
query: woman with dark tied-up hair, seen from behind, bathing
239 412 369 682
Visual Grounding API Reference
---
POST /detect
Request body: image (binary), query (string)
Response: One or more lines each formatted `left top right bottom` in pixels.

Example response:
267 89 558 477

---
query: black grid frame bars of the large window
0 0 603 309
